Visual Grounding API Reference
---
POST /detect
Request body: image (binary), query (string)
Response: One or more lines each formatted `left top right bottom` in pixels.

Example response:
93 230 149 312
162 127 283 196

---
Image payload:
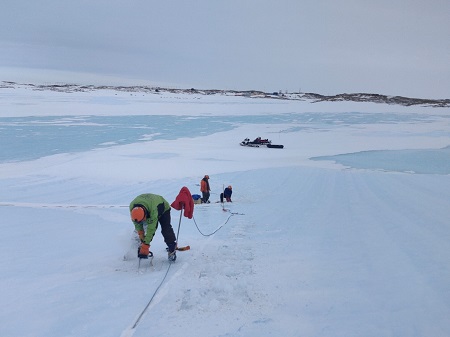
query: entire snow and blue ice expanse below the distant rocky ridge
0 88 450 337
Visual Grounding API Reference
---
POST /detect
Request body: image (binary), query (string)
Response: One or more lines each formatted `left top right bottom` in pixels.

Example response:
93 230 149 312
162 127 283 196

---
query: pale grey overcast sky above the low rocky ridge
0 0 450 98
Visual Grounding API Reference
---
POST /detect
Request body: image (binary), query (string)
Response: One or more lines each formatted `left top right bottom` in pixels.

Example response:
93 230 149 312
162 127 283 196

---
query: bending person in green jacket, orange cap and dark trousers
130 193 177 261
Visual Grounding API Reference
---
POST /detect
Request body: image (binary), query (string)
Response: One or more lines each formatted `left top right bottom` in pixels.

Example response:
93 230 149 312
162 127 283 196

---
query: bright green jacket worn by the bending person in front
130 193 170 244
